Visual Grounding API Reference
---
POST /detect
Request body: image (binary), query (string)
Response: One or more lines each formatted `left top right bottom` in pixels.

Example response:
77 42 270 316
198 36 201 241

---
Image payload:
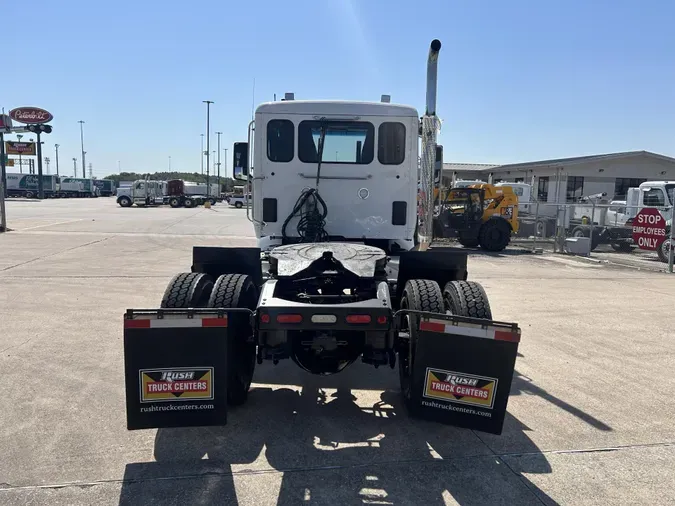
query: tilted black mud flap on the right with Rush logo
404 315 520 434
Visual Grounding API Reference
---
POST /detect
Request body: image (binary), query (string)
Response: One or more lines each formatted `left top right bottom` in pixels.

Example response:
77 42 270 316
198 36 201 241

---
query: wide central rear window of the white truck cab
298 121 375 165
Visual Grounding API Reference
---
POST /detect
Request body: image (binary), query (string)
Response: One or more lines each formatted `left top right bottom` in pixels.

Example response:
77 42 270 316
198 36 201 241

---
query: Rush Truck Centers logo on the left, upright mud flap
139 367 213 402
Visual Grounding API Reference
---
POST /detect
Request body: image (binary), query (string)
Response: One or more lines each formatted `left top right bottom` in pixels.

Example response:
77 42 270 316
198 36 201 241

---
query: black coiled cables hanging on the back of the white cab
281 122 329 242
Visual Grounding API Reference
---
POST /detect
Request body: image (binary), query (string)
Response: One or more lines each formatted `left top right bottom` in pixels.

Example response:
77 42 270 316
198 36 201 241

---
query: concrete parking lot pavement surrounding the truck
0 198 675 506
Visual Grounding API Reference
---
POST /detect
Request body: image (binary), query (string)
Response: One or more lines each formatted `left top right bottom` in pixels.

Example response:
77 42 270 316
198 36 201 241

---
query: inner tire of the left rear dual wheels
208 274 258 406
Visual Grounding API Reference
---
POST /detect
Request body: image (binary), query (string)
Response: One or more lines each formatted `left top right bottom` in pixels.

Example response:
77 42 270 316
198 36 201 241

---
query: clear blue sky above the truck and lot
0 0 675 177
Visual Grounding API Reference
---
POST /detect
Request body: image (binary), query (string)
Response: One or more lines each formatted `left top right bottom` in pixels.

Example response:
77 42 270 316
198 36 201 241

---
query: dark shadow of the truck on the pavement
120 364 576 505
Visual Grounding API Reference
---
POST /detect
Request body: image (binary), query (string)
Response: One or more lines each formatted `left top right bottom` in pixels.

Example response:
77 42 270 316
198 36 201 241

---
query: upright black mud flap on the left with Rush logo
124 309 234 430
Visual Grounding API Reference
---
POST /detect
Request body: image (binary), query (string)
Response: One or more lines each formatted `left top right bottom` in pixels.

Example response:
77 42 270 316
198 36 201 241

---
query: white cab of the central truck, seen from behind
246 99 420 250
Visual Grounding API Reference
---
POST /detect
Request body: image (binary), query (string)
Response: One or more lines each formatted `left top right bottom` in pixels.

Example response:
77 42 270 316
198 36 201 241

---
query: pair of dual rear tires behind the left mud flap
160 272 258 406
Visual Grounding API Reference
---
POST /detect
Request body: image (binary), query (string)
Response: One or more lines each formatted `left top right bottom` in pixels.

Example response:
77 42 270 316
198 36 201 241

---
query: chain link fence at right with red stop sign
511 202 675 272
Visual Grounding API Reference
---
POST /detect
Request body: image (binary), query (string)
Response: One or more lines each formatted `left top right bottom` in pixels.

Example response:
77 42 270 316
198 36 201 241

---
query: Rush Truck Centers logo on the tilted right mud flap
424 367 497 409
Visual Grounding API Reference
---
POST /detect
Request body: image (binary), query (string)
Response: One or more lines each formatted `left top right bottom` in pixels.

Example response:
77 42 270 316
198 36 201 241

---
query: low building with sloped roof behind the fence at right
443 151 675 203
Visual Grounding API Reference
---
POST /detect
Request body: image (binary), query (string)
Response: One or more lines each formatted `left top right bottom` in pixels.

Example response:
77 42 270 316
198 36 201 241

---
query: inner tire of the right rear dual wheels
398 279 445 414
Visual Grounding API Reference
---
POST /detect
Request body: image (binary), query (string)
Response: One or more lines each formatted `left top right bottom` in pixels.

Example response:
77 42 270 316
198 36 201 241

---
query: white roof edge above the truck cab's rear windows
256 100 419 118
